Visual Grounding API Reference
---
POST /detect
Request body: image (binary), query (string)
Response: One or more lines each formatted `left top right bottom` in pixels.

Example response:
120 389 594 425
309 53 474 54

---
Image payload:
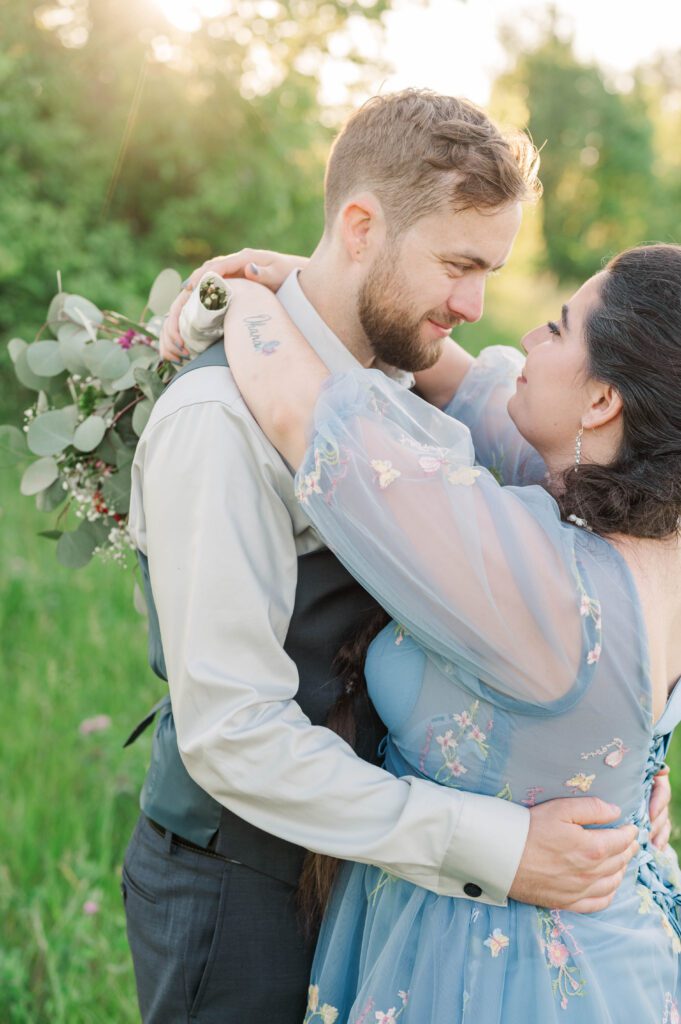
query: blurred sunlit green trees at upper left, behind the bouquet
0 0 389 420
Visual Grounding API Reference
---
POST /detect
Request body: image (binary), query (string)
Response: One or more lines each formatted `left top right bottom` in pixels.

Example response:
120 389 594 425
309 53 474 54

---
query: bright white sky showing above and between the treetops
147 0 681 105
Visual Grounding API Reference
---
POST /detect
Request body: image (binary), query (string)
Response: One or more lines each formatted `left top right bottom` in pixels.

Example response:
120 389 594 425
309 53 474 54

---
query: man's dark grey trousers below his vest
121 816 313 1024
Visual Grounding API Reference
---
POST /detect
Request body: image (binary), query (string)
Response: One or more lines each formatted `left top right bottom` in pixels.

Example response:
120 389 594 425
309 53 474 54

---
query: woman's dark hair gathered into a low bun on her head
558 245 681 538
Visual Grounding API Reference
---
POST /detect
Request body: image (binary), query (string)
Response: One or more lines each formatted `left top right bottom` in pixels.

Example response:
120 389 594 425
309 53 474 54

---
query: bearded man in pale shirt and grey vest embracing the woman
123 90 659 1024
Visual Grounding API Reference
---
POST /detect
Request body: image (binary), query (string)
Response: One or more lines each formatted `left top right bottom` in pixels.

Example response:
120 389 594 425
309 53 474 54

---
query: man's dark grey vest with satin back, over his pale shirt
126 343 384 885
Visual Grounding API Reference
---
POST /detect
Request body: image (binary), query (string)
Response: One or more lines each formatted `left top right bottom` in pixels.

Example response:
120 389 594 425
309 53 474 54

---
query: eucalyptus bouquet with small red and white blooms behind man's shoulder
0 269 183 568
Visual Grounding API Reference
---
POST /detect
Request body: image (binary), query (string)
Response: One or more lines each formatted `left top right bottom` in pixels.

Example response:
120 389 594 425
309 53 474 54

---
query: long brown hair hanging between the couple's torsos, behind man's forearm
298 608 390 937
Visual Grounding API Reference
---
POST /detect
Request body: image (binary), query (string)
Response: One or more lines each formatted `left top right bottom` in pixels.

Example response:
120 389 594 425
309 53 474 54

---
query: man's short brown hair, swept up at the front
325 89 542 236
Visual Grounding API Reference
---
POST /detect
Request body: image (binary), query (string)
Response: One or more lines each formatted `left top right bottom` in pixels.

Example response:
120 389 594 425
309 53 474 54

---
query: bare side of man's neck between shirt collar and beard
298 254 374 367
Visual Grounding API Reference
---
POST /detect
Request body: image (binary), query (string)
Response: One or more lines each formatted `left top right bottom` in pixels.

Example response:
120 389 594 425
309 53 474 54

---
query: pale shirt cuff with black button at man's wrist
438 793 529 906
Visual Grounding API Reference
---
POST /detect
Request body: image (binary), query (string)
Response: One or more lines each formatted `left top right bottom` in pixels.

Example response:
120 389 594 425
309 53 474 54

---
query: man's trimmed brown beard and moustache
357 248 461 372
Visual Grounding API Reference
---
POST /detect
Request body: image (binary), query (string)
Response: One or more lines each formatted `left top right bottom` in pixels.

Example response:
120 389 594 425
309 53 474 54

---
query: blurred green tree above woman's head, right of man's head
495 14 661 280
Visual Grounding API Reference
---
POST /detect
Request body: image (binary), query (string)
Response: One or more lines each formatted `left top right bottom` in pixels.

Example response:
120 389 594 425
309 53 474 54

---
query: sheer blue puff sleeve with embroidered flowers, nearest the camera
296 370 601 714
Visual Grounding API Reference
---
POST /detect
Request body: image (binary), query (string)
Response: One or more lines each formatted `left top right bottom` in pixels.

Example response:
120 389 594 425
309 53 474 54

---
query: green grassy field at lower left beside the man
0 460 681 1024
